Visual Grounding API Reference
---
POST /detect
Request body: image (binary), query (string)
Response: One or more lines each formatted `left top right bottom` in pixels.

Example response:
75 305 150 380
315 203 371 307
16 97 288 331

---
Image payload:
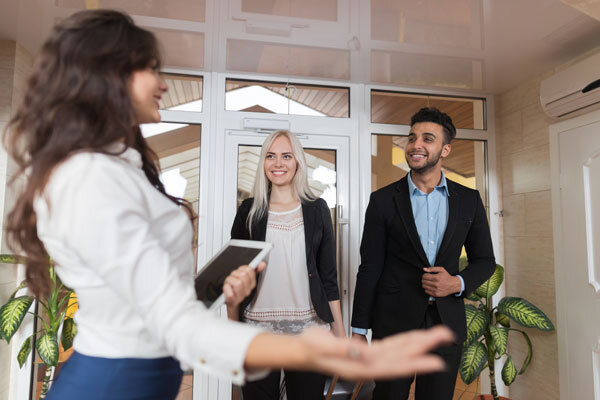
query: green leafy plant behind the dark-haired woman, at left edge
0 254 77 398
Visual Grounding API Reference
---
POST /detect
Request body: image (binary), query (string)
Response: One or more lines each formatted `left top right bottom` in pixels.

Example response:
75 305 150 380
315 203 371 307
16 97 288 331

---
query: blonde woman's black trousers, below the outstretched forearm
242 370 326 400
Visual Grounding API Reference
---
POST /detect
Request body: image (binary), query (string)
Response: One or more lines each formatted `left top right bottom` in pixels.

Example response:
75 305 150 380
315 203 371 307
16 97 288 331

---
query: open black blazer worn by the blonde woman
231 198 340 323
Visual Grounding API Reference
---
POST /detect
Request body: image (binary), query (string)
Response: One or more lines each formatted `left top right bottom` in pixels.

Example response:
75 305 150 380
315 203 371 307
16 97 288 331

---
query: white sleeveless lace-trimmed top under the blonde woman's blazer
244 205 327 334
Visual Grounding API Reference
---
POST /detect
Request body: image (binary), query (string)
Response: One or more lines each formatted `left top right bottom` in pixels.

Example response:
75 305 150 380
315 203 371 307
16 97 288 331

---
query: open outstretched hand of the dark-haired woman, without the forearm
300 327 453 380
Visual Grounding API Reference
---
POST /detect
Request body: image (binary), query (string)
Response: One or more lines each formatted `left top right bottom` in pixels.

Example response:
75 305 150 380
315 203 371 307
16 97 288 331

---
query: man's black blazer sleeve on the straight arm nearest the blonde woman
351 192 387 329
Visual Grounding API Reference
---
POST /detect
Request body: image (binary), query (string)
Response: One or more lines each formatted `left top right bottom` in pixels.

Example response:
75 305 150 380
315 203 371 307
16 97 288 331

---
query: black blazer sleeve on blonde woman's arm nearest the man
316 199 340 301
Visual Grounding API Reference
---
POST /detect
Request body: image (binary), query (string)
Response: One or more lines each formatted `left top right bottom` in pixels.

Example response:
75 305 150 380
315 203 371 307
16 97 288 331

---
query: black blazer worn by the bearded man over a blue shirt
352 177 496 343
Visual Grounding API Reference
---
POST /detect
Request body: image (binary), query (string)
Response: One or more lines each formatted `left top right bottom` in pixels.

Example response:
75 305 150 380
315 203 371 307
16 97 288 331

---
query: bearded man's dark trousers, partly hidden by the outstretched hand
373 302 462 400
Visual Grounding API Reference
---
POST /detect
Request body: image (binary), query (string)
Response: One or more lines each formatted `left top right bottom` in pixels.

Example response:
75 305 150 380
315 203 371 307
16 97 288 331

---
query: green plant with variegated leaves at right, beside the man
460 265 554 400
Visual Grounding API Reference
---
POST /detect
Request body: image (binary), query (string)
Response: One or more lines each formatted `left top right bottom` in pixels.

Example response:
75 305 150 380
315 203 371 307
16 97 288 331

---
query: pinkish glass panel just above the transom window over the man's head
371 50 484 89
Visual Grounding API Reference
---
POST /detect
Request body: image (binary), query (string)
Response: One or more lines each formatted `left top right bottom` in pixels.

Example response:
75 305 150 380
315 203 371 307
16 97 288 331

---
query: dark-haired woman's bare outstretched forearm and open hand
244 327 452 379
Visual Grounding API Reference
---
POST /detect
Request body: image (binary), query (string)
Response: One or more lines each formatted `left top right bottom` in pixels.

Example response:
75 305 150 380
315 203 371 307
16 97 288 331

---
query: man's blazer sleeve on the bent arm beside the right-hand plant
460 192 496 297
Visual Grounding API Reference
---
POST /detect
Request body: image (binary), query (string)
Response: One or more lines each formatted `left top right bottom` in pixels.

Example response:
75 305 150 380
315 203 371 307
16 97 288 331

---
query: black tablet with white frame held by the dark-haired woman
194 239 273 310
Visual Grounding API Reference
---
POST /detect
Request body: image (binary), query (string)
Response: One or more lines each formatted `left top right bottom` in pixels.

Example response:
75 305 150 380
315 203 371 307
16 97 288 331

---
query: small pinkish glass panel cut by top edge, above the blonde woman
242 0 337 21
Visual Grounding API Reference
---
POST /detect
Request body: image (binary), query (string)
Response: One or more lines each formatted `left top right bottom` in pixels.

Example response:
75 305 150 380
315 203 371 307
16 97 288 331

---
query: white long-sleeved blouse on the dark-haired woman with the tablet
34 145 260 384
